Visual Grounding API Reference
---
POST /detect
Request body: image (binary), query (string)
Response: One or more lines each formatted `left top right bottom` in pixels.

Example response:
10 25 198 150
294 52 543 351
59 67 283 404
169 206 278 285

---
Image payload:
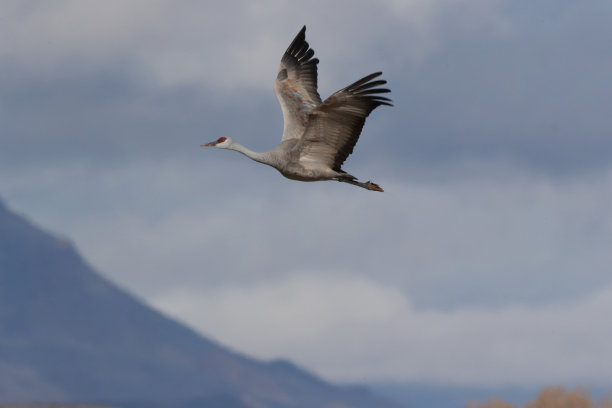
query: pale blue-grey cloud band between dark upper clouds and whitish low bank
0 159 612 308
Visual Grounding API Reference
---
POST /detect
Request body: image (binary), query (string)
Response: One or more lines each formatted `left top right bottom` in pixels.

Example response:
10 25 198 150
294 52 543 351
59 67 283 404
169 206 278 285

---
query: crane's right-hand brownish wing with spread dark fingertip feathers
300 72 393 171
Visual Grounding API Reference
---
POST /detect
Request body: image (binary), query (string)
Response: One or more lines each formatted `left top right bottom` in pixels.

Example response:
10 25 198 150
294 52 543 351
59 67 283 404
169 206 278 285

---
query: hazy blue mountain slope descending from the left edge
0 196 402 408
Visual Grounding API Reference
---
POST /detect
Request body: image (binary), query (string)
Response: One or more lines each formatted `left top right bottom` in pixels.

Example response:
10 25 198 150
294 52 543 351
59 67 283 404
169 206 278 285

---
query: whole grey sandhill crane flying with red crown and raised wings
202 26 393 191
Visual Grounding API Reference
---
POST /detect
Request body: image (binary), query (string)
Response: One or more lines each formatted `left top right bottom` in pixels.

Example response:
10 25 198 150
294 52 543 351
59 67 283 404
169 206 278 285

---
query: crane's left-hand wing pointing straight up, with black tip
274 26 321 140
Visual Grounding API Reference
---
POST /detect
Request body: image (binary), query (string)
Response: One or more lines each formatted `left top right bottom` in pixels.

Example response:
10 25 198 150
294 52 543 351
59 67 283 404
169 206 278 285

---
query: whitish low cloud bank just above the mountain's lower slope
156 274 612 386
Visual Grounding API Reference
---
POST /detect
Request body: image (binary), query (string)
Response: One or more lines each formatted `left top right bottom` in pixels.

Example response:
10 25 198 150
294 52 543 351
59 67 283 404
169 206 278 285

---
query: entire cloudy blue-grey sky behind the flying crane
0 0 612 385
